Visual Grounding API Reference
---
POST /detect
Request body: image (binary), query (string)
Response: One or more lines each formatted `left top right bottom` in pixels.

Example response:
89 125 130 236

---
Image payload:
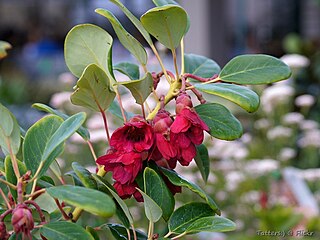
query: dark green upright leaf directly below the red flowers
143 167 175 221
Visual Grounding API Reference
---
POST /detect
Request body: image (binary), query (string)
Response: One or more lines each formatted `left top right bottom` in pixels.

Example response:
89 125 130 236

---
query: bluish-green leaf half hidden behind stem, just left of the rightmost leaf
184 54 220 78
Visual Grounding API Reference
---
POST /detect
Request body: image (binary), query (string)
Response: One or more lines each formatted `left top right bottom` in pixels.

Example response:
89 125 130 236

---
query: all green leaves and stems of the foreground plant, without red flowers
0 0 290 240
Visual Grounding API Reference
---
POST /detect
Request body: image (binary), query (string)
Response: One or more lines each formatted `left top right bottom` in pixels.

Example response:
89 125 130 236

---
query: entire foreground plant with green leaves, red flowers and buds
0 0 291 240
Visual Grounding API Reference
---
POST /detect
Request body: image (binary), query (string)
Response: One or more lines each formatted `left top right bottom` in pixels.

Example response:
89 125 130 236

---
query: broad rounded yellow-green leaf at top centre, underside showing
141 5 188 50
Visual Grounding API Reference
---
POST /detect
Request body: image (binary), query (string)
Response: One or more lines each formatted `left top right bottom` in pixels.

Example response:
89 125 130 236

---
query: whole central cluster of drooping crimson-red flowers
97 93 209 201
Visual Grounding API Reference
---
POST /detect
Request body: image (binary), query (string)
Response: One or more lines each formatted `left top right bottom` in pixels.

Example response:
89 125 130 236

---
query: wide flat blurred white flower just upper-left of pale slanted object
244 159 279 176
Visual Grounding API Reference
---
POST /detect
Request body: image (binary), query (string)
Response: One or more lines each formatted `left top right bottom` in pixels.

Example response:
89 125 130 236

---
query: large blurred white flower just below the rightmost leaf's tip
261 84 294 113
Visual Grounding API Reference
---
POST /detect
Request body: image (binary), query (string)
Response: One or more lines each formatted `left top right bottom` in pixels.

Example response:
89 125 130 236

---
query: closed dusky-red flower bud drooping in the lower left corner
11 204 34 236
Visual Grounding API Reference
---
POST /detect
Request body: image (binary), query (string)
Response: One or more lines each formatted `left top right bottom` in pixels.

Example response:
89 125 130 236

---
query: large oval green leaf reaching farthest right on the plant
219 54 291 84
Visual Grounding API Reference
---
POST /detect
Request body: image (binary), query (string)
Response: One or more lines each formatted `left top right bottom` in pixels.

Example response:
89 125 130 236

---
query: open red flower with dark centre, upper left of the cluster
110 116 154 152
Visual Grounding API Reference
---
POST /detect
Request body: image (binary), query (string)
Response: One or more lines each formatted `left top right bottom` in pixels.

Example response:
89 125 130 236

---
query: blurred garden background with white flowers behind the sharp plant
0 0 320 240
